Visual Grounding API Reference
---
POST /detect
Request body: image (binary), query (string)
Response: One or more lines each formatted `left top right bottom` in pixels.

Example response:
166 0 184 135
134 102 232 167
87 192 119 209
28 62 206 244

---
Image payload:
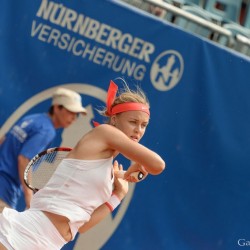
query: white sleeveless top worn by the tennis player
30 157 114 238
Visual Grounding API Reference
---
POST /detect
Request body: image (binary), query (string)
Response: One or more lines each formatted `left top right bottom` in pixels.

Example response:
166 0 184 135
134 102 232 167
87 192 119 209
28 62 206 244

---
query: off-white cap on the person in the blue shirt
52 88 87 114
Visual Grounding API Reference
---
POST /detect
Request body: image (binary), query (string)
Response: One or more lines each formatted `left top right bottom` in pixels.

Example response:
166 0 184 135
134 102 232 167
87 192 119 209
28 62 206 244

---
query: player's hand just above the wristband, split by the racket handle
113 161 129 200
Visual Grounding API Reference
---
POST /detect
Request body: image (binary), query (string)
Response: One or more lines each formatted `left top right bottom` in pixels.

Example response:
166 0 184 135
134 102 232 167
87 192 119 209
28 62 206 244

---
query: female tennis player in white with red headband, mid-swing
0 81 165 250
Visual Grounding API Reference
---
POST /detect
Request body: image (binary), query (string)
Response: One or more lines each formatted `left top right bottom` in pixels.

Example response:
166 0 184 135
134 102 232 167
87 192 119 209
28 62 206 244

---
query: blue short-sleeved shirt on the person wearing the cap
0 114 56 208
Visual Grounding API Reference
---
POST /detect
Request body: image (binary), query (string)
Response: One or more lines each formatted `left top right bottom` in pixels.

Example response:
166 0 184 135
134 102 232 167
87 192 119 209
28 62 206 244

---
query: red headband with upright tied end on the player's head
106 81 150 116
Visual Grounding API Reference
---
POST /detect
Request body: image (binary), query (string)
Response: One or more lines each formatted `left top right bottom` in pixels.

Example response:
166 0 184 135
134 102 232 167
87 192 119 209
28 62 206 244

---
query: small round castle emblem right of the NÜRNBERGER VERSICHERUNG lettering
150 50 184 91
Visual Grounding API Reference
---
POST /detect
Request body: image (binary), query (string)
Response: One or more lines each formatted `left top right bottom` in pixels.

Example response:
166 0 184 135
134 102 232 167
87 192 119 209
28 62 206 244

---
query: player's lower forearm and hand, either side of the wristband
78 161 128 233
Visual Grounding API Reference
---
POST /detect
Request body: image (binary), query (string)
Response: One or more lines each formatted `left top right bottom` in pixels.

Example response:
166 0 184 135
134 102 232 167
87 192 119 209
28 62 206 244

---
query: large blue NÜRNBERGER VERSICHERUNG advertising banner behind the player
0 0 250 250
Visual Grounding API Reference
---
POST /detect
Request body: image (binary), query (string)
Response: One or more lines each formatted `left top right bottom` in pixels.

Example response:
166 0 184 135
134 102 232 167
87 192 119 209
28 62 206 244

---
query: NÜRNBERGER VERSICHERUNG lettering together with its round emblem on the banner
30 0 183 88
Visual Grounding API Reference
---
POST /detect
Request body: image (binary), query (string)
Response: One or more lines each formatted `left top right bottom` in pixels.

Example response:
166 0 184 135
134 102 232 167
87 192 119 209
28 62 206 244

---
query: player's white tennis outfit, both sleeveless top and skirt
0 157 114 250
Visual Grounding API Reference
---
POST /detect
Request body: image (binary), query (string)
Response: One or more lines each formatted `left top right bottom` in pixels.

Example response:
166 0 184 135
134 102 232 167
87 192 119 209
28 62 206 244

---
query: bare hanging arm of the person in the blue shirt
18 155 33 208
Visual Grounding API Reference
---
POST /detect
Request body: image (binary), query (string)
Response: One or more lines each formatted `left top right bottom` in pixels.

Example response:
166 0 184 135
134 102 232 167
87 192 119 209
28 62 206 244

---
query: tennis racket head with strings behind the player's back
24 147 72 192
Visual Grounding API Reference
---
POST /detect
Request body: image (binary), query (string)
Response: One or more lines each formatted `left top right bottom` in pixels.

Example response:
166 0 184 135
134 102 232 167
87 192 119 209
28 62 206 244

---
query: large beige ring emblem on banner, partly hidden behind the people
0 84 135 250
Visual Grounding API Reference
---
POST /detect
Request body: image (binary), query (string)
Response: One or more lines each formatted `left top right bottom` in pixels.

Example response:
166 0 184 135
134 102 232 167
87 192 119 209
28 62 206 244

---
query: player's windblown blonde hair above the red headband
97 82 150 122
